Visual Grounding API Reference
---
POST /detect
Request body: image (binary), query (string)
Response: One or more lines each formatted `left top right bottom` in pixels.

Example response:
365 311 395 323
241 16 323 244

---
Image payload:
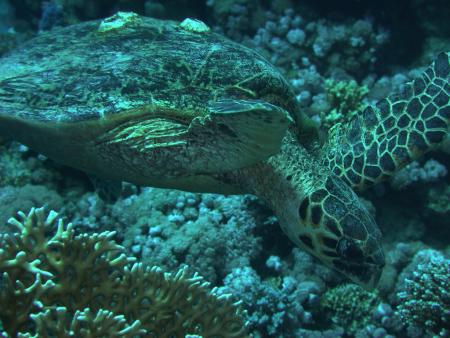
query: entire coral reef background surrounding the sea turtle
0 0 450 338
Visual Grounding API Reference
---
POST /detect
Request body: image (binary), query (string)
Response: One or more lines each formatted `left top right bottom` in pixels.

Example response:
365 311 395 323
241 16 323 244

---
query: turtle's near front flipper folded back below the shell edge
94 100 291 182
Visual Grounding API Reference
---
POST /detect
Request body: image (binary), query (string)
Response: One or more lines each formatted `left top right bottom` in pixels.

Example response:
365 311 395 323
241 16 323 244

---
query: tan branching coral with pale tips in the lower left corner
0 208 246 337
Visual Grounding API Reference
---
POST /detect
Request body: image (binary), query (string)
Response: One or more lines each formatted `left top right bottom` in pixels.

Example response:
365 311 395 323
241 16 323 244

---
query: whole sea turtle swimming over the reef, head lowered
0 13 450 287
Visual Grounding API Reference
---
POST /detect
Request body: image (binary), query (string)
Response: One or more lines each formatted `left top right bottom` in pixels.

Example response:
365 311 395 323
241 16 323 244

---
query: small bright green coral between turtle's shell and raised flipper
321 79 369 129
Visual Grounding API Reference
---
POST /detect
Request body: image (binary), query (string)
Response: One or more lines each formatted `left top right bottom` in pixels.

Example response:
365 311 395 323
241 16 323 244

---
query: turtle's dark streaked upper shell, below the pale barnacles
0 13 296 126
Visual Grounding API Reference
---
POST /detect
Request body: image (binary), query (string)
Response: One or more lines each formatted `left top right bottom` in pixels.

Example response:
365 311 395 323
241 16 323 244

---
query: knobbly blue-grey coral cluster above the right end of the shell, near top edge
244 9 387 75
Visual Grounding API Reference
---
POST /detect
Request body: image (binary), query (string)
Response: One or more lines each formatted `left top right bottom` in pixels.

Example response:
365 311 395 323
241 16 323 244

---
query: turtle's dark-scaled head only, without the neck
296 175 385 288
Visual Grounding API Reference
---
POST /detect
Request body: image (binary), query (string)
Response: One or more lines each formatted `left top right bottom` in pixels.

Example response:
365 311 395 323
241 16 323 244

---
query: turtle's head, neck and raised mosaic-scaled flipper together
225 53 450 288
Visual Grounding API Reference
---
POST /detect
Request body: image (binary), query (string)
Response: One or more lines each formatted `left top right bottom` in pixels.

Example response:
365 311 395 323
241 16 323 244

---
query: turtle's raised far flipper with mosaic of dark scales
322 52 450 190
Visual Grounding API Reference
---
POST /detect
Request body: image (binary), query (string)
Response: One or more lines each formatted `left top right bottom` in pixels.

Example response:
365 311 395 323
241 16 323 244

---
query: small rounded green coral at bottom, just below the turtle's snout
321 284 380 334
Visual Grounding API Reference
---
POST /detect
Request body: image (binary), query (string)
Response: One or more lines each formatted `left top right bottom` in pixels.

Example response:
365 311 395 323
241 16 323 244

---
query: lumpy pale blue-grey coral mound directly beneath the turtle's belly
109 188 264 283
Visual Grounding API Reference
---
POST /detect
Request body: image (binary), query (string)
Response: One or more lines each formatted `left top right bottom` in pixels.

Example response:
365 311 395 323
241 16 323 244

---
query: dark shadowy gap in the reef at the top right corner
294 0 450 73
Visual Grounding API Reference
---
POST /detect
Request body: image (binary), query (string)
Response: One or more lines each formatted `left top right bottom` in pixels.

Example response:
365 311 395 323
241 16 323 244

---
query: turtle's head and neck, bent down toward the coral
217 131 385 289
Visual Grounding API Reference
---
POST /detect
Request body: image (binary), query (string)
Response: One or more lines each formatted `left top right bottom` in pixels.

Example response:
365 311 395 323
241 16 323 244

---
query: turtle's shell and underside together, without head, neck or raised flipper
0 13 295 190
